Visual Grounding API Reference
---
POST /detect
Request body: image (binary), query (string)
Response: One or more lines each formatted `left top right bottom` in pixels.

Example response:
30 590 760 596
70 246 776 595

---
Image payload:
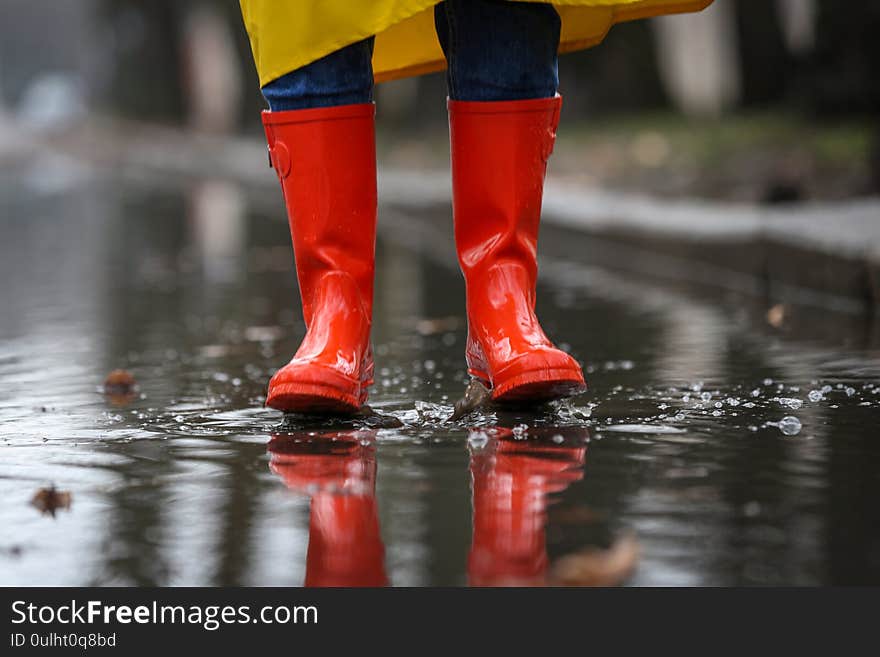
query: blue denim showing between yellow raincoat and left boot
262 37 375 112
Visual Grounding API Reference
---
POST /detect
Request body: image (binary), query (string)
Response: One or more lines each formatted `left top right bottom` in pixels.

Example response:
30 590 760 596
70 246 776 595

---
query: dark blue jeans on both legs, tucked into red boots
263 0 560 112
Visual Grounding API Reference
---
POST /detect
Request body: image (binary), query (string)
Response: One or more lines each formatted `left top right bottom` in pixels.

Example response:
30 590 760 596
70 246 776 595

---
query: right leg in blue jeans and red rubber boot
435 0 585 402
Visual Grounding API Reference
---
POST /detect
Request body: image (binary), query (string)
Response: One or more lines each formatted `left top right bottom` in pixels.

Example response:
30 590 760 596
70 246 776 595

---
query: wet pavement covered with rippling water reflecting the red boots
0 169 880 586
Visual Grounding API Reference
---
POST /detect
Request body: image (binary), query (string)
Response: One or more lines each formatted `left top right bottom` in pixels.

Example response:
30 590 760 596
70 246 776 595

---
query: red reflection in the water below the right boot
468 428 587 586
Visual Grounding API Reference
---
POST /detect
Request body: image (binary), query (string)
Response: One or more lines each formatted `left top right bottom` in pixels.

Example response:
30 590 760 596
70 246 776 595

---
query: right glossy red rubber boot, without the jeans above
449 96 586 402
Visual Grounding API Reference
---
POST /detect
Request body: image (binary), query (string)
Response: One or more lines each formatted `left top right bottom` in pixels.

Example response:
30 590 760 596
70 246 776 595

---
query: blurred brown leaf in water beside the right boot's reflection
548 533 639 586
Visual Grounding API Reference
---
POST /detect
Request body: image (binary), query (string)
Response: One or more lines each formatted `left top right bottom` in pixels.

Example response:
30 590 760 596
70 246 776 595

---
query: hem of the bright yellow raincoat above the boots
240 0 712 85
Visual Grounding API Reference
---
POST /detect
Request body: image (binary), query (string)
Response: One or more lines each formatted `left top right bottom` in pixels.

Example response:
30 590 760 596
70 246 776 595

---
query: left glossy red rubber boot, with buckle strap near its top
263 103 376 413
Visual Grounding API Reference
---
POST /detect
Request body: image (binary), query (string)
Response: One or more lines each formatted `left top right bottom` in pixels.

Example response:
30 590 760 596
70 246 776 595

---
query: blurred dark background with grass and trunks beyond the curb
0 0 880 201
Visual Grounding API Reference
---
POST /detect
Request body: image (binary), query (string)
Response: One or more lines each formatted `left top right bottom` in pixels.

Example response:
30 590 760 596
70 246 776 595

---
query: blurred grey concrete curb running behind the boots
6 119 880 315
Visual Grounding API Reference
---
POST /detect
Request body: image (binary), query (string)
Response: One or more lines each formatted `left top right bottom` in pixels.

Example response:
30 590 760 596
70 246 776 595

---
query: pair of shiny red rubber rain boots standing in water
263 96 585 413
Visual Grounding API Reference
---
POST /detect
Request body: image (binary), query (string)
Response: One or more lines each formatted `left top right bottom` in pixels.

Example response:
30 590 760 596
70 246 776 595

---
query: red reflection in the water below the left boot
269 431 388 586
